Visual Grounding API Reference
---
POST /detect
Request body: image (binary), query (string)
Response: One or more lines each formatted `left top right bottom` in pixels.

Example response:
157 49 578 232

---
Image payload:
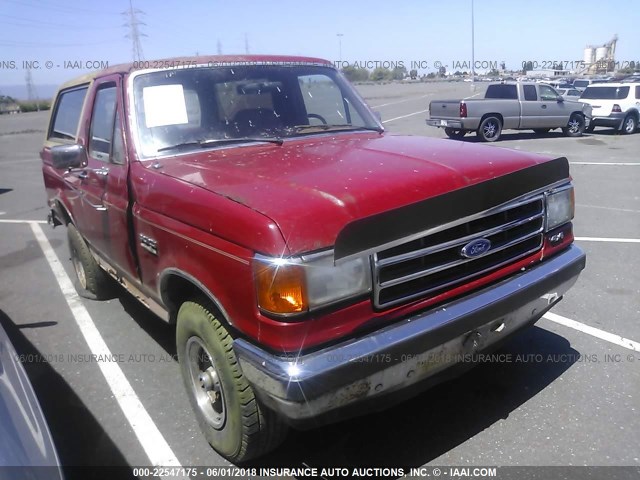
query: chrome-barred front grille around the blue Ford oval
374 195 545 308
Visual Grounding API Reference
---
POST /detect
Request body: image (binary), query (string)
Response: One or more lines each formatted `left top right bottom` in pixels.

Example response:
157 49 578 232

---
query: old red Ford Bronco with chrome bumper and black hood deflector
41 56 585 462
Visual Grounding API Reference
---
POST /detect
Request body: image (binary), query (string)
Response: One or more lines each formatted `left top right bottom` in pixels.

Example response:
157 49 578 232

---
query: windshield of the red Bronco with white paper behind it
133 65 381 157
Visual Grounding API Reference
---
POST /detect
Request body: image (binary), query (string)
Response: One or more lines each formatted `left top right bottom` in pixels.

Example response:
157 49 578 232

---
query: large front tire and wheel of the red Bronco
176 301 287 462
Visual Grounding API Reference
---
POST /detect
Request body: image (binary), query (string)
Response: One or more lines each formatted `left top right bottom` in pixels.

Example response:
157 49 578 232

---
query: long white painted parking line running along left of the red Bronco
30 222 181 468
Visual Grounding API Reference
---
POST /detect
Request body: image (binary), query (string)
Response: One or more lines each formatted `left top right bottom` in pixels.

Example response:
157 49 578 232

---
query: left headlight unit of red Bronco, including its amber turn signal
253 251 371 314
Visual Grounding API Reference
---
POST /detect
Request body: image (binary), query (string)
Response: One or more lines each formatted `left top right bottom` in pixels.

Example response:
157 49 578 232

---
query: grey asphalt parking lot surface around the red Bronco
0 83 640 478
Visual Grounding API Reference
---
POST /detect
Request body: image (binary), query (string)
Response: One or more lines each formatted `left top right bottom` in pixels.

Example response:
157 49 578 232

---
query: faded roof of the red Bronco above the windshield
59 55 333 90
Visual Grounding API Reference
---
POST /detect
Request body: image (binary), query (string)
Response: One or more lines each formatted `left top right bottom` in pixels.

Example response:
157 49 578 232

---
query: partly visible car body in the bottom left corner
0 325 63 480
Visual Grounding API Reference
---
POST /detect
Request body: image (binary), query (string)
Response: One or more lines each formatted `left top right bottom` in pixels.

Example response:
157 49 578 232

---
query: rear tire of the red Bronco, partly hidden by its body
67 223 112 300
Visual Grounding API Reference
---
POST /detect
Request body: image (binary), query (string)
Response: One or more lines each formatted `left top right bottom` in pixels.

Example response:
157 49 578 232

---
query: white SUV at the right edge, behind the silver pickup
580 82 640 134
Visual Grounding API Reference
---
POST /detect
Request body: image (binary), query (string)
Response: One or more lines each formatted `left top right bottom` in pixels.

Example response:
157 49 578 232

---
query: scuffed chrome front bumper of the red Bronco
234 245 586 425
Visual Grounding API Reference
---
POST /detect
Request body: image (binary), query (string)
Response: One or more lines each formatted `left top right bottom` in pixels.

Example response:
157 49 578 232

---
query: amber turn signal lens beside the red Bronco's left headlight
253 261 309 314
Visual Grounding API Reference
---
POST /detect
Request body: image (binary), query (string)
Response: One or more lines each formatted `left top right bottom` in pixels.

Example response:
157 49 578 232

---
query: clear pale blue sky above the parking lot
0 0 640 94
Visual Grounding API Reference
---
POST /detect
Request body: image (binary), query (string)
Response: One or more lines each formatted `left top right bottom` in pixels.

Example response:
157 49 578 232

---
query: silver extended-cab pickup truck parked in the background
427 82 591 142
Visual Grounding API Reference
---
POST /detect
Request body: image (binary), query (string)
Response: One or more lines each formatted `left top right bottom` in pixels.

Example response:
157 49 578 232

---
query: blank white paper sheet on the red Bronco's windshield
142 85 189 128
